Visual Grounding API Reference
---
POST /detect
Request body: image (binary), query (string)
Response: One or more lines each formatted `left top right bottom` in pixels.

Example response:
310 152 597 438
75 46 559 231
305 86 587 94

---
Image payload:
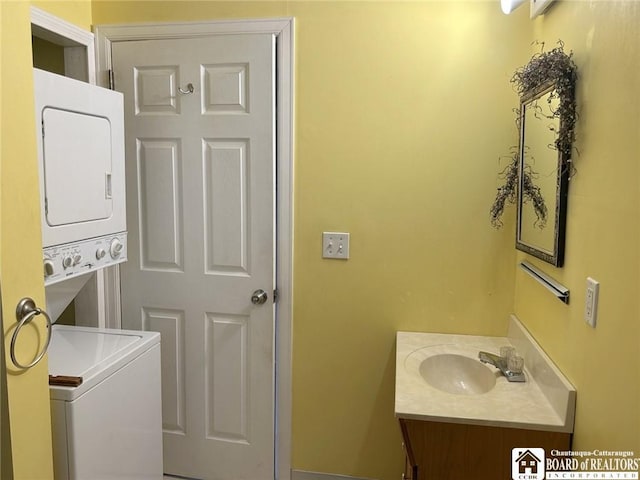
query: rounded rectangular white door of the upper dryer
42 108 113 226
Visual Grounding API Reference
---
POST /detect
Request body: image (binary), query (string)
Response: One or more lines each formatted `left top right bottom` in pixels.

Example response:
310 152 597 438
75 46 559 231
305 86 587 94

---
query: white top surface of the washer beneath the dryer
49 325 160 401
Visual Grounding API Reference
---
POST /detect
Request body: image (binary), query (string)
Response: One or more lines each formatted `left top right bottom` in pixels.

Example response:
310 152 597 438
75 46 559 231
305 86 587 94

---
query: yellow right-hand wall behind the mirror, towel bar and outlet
515 1 640 452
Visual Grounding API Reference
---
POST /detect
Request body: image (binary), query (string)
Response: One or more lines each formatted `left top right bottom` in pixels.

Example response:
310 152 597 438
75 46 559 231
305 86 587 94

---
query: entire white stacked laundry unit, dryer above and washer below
34 69 162 480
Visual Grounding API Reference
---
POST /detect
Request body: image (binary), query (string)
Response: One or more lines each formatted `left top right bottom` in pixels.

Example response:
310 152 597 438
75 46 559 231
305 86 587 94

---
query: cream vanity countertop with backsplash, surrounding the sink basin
395 317 576 433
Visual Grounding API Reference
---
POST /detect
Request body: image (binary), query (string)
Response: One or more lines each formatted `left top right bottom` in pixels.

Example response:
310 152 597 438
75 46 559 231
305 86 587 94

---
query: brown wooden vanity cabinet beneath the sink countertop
400 418 571 480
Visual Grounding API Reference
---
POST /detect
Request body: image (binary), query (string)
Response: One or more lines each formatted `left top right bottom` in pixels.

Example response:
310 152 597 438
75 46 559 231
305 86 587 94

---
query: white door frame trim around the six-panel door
94 18 294 480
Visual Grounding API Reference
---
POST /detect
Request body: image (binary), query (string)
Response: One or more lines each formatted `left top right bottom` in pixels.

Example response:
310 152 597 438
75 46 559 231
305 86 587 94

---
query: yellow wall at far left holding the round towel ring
0 1 90 480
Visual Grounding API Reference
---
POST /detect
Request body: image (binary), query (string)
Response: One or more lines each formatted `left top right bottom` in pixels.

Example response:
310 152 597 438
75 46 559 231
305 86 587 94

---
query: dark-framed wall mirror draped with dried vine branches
491 41 577 266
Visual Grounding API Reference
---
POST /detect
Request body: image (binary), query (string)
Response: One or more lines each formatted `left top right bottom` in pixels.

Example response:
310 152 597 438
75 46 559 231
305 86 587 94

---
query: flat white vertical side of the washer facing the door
66 345 163 480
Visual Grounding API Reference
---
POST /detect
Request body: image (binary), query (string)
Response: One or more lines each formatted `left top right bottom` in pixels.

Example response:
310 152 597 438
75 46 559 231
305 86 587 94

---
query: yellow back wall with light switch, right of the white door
93 1 530 480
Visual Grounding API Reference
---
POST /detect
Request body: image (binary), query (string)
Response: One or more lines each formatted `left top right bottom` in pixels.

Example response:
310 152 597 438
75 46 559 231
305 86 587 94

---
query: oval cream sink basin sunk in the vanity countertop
419 353 496 395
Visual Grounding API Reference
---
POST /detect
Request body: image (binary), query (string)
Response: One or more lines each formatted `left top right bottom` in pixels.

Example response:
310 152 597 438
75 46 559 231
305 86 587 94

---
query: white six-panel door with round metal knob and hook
112 34 275 480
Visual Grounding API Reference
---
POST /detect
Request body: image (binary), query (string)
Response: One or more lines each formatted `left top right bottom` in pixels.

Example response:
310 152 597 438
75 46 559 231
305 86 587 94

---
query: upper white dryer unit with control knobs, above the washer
33 68 127 320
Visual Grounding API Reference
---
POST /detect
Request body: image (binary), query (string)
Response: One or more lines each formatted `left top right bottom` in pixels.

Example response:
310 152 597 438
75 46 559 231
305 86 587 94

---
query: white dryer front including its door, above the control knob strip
33 68 126 251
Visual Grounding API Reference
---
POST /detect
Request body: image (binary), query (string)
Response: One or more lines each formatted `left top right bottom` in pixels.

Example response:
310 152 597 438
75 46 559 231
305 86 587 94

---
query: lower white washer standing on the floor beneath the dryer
49 325 162 480
